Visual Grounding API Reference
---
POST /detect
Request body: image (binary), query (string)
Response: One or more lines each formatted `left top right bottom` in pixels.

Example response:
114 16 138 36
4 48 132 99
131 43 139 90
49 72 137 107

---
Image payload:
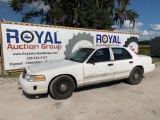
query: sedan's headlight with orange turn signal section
25 74 45 82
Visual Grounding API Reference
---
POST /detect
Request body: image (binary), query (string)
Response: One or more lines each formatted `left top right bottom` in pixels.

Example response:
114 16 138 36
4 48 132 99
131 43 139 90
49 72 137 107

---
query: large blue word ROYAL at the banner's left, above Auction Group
6 29 61 44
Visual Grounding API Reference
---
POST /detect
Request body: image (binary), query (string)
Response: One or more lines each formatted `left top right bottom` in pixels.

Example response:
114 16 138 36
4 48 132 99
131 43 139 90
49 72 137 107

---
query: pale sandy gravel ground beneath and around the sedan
0 63 160 120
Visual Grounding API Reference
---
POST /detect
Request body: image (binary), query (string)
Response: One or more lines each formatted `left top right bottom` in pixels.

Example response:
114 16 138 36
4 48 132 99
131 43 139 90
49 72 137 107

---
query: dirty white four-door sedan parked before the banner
19 46 155 99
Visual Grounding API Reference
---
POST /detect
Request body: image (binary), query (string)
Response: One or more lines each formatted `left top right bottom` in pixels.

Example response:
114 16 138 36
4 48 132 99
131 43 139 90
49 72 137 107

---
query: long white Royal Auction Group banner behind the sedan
1 24 138 70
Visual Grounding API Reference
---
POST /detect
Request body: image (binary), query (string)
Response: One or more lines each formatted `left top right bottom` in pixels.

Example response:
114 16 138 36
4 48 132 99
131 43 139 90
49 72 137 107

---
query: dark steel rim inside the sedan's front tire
56 80 70 95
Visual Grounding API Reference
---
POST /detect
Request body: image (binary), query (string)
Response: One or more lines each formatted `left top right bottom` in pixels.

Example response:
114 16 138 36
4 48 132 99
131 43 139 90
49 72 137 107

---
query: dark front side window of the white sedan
91 48 110 62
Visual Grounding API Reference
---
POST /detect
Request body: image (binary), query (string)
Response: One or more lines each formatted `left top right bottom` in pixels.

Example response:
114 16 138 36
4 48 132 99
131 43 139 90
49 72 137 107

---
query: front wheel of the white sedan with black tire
49 75 75 99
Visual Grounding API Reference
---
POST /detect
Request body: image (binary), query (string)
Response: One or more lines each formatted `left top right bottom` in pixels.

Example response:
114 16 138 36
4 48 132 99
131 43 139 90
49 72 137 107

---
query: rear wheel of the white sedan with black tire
127 67 143 85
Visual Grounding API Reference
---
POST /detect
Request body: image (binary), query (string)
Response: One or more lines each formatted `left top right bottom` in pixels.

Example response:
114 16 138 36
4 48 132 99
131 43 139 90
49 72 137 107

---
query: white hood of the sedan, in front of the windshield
28 59 79 73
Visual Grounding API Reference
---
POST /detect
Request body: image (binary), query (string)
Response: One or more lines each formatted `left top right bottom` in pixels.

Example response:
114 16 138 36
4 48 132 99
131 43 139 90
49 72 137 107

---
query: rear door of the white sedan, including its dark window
112 48 134 79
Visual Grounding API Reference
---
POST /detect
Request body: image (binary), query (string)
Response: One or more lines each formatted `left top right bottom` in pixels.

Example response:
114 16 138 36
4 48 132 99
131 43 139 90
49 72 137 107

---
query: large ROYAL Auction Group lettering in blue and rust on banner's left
6 29 62 50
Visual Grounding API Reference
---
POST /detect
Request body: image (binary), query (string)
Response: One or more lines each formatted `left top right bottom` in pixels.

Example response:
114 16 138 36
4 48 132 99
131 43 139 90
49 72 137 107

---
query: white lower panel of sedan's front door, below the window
84 61 114 85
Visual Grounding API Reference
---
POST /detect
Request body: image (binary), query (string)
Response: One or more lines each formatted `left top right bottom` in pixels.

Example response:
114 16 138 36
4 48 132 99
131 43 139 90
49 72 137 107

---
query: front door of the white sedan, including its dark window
83 48 114 85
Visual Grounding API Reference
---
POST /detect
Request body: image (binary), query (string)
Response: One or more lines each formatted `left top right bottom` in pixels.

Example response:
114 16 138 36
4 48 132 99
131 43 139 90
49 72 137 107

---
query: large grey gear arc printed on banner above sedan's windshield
64 32 94 57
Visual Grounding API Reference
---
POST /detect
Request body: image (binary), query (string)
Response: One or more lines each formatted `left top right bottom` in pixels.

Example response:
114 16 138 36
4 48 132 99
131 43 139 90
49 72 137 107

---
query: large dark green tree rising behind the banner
9 0 138 30
